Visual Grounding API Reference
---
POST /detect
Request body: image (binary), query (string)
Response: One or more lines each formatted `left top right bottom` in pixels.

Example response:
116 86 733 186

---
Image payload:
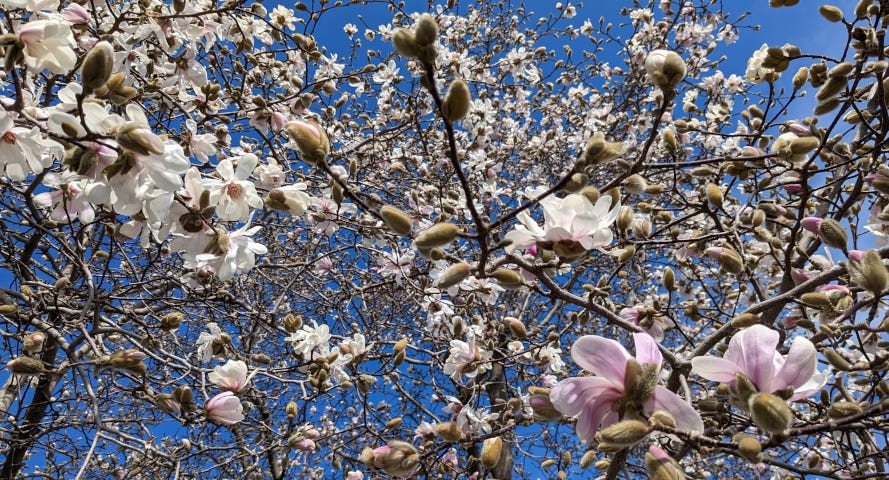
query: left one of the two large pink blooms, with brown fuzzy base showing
550 333 704 442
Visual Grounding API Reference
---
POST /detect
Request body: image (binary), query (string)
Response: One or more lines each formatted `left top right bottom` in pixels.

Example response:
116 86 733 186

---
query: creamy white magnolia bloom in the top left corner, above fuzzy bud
18 18 77 75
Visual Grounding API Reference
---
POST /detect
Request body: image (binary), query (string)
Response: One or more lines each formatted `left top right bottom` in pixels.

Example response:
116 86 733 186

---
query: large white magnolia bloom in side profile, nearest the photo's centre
506 192 620 261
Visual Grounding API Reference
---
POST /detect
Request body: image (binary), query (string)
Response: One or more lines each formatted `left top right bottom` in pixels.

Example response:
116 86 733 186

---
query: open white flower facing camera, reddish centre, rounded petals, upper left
204 153 262 222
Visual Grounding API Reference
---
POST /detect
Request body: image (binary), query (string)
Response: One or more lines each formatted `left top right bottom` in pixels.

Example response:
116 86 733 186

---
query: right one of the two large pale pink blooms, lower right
691 325 825 400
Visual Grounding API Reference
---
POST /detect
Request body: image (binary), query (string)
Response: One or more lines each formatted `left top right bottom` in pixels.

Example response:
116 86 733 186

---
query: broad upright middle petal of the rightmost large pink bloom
723 325 779 392
